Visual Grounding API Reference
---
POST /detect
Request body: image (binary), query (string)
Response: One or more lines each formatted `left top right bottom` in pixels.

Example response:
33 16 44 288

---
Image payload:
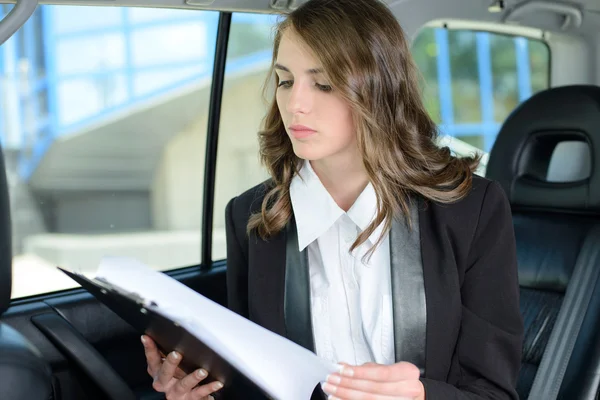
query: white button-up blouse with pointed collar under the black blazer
290 161 394 365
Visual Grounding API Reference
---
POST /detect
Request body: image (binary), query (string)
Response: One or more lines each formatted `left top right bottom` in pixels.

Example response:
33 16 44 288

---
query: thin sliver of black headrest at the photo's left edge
0 148 10 315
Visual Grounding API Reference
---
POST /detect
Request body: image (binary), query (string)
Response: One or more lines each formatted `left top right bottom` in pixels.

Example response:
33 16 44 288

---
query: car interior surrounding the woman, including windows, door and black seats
0 0 600 400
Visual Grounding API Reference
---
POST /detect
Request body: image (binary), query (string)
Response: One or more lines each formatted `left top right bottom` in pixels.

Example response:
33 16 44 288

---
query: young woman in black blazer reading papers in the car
145 0 523 400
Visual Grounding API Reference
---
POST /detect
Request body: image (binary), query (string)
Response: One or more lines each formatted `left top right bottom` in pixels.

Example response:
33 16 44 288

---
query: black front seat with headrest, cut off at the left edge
0 144 52 400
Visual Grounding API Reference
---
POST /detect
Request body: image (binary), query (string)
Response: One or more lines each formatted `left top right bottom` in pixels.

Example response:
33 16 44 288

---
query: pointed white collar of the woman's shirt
290 161 383 251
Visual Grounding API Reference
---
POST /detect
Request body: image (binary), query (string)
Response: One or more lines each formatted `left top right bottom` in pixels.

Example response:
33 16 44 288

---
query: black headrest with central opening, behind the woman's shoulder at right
486 85 600 214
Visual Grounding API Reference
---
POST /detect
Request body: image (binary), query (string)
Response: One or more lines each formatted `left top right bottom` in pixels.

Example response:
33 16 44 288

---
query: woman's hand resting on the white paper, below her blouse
323 362 425 400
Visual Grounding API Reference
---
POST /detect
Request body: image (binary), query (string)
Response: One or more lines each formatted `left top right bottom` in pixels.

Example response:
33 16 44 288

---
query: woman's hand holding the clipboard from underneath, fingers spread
142 336 223 400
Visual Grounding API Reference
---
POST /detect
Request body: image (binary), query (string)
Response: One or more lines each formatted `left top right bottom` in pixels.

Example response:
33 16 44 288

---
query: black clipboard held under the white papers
57 267 269 399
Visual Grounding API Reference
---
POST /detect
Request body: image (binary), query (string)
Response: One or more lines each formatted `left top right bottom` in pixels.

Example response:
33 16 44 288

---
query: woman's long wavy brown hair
247 0 480 255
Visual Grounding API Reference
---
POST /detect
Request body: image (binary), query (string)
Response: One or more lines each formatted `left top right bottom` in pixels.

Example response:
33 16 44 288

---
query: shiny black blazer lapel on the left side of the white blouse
284 217 315 352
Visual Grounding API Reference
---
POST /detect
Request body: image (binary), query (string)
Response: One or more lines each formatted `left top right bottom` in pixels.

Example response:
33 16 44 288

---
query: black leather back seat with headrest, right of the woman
486 85 600 399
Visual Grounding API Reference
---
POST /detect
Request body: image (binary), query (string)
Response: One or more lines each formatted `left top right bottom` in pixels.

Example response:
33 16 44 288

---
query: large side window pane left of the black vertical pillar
5 5 219 298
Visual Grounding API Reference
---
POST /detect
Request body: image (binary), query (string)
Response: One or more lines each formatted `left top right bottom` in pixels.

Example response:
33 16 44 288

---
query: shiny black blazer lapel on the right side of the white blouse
390 201 427 375
